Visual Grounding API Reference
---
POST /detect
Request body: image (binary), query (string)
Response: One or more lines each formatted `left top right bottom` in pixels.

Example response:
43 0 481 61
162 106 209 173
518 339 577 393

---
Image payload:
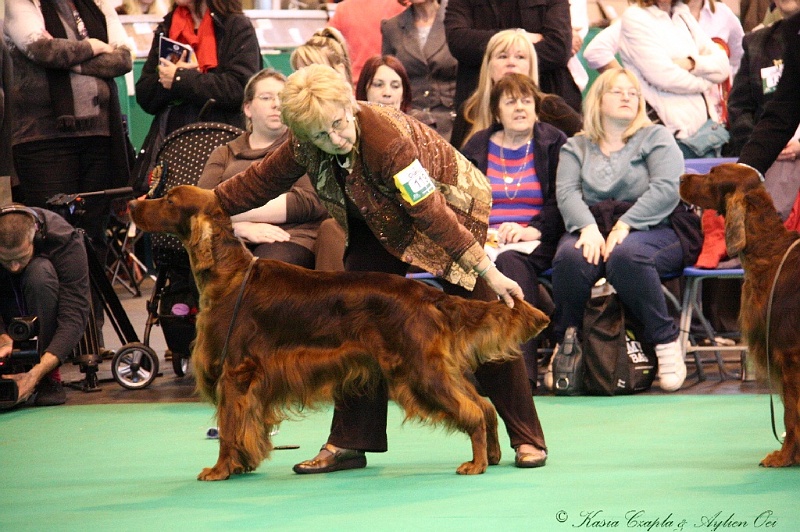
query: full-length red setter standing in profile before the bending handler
130 186 549 480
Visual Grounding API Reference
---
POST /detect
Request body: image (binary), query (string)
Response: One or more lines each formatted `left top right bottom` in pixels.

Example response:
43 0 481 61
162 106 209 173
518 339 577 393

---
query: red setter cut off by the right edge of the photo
680 164 800 467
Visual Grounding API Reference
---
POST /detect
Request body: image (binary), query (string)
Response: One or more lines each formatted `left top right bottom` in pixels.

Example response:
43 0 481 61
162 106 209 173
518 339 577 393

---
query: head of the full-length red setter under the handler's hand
129 185 241 273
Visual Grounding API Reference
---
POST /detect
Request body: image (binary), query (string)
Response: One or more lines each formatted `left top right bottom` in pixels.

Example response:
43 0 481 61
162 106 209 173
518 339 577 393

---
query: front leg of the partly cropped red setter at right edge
759 351 800 467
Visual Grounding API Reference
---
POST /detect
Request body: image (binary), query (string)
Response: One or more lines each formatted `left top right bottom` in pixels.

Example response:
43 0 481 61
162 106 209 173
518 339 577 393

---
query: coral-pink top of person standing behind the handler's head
328 0 405 85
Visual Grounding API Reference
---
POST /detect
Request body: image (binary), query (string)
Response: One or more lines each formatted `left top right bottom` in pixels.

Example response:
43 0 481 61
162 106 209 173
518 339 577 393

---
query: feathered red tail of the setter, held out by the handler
444 298 550 369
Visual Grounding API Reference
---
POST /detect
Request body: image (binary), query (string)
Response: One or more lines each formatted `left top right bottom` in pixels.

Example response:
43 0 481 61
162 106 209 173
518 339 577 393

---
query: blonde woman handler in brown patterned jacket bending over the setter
215 65 547 473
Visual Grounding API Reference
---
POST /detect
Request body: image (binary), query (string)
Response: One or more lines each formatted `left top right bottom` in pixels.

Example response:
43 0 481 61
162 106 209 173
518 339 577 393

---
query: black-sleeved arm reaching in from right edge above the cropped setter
739 13 800 175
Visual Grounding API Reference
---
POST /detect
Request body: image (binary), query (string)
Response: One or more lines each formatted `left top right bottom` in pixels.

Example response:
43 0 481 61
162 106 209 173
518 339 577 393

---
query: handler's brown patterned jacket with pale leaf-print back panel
214 102 492 290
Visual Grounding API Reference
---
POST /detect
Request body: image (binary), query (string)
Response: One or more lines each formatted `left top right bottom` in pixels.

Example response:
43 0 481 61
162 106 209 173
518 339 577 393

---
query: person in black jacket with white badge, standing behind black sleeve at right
728 0 800 219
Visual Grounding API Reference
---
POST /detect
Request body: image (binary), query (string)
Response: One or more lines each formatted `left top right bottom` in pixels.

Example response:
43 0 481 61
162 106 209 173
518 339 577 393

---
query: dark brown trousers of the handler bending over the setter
328 219 547 452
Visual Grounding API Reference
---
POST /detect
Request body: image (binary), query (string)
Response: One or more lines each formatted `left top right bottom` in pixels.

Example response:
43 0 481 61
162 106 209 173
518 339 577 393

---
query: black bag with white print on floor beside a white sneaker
582 293 656 395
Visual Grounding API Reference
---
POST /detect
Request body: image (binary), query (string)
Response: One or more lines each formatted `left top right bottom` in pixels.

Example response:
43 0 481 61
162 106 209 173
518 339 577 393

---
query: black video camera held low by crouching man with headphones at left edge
0 316 41 408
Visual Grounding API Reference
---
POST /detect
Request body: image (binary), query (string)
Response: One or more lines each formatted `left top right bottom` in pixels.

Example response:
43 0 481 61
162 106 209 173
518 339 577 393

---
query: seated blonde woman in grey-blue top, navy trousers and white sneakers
553 69 686 391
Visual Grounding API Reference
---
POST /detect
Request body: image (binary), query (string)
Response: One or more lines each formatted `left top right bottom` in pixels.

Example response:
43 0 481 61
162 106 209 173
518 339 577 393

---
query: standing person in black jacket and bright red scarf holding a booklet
136 0 262 139
